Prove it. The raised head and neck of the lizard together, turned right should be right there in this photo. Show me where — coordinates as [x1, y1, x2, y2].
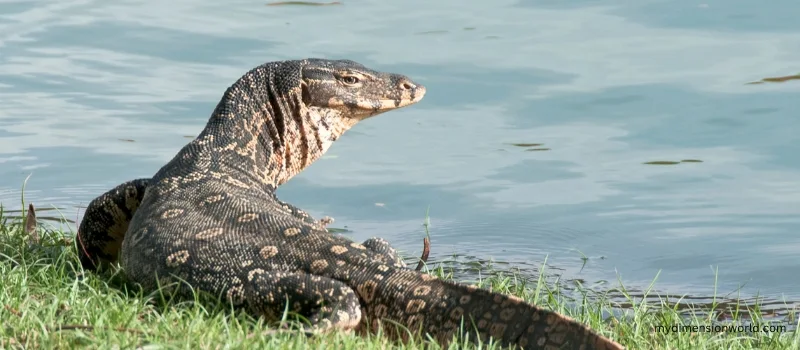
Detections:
[195, 58, 425, 188]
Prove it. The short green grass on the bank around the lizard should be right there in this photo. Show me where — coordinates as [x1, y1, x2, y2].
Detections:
[0, 204, 800, 349]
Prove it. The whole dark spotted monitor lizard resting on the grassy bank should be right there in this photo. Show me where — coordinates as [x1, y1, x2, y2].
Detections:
[78, 59, 622, 349]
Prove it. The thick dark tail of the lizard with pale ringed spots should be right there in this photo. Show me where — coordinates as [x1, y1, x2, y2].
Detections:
[358, 270, 624, 350]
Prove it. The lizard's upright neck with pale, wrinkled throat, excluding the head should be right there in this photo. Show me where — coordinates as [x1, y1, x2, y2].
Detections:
[198, 66, 357, 190]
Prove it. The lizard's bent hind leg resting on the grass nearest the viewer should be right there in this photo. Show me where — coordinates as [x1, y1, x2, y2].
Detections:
[244, 269, 361, 331]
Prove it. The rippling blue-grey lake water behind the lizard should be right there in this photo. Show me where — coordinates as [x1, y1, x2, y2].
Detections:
[0, 0, 800, 308]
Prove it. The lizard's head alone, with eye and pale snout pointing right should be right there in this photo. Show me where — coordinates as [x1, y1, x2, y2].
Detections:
[302, 59, 425, 122]
